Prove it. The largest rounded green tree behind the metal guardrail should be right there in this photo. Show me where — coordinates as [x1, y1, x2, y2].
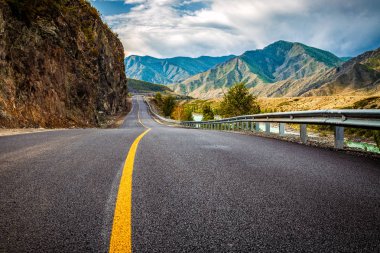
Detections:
[220, 83, 260, 117]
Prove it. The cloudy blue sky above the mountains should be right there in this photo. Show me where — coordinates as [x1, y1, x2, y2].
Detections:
[90, 0, 380, 58]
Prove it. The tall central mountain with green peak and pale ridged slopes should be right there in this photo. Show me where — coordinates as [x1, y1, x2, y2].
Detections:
[170, 41, 342, 98]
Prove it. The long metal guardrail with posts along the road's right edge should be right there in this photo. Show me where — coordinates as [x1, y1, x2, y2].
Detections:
[180, 109, 380, 149]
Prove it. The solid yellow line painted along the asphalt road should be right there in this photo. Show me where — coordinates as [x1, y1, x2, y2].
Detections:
[109, 128, 151, 252]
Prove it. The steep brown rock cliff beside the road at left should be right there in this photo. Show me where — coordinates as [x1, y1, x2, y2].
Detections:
[0, 0, 128, 127]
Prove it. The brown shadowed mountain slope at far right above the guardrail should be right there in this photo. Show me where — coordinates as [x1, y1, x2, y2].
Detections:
[251, 49, 380, 97]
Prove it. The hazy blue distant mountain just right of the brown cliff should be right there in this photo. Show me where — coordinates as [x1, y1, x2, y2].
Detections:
[125, 55, 234, 84]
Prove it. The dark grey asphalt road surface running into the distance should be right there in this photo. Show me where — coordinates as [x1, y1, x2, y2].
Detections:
[0, 98, 380, 252]
